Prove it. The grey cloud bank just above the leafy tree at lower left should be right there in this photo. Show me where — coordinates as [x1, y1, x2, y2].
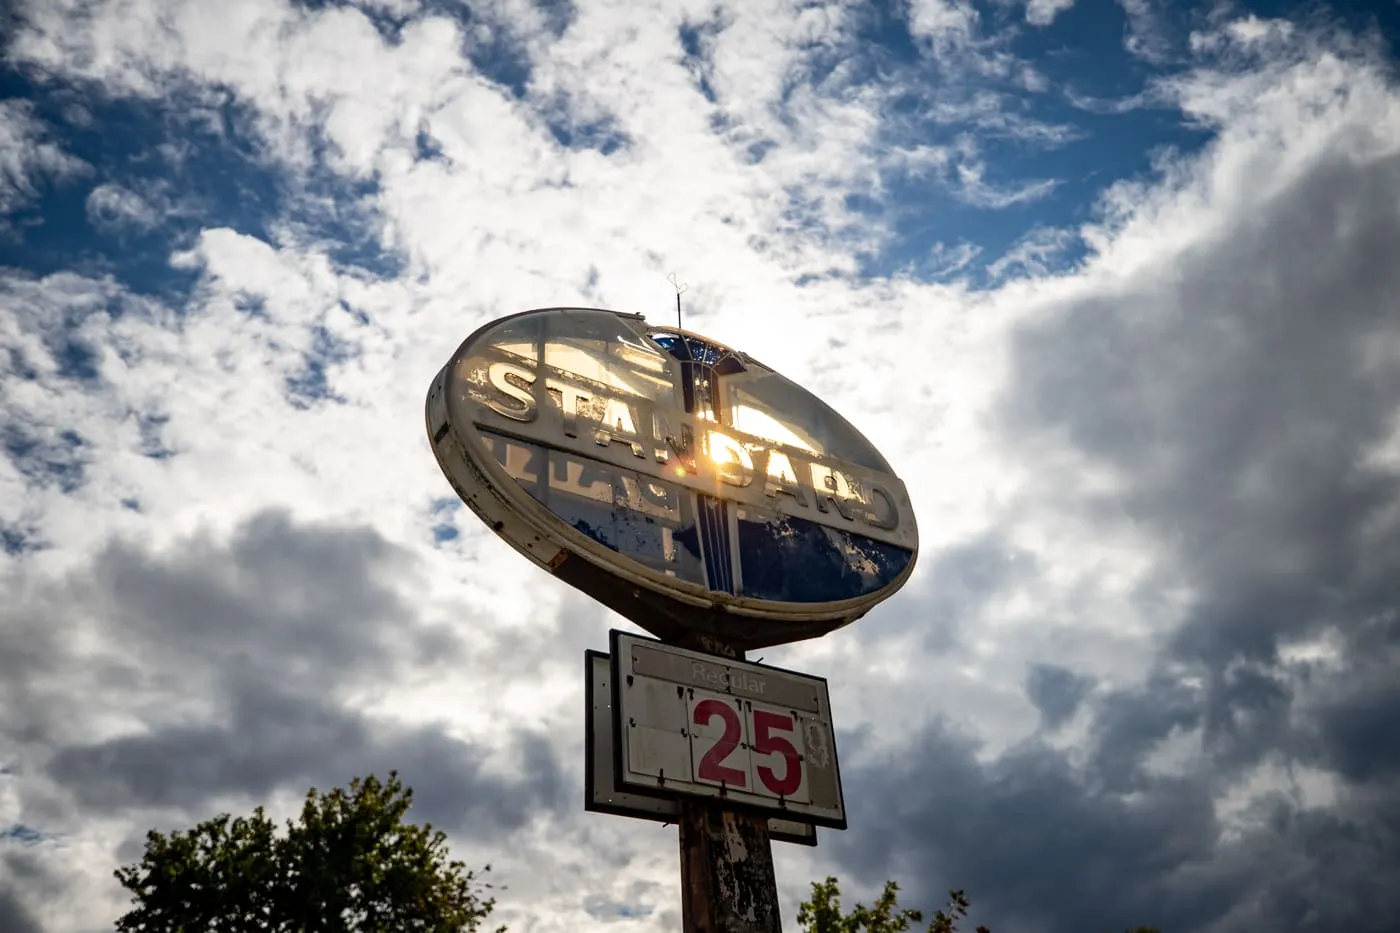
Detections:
[0, 513, 564, 835]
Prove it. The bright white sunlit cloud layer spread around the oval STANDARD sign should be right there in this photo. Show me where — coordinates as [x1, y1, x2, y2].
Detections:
[0, 0, 1400, 930]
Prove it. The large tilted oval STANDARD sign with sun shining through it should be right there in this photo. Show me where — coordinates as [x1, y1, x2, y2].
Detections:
[427, 308, 918, 650]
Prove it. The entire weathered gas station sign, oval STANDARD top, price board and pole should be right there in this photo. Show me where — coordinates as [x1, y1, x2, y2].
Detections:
[427, 308, 918, 933]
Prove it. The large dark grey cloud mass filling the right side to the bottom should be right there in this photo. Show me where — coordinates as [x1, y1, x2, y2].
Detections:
[833, 67, 1400, 933]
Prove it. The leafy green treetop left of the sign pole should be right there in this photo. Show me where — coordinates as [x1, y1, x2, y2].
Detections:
[116, 772, 505, 933]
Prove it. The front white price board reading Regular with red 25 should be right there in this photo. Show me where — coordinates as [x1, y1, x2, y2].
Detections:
[612, 630, 846, 829]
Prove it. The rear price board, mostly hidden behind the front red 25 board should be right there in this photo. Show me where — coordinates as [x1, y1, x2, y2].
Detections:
[584, 651, 816, 846]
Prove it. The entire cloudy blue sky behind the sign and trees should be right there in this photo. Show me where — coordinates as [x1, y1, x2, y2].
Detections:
[0, 0, 1400, 933]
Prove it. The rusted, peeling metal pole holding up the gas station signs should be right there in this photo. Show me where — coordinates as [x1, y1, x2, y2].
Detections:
[678, 635, 783, 933]
